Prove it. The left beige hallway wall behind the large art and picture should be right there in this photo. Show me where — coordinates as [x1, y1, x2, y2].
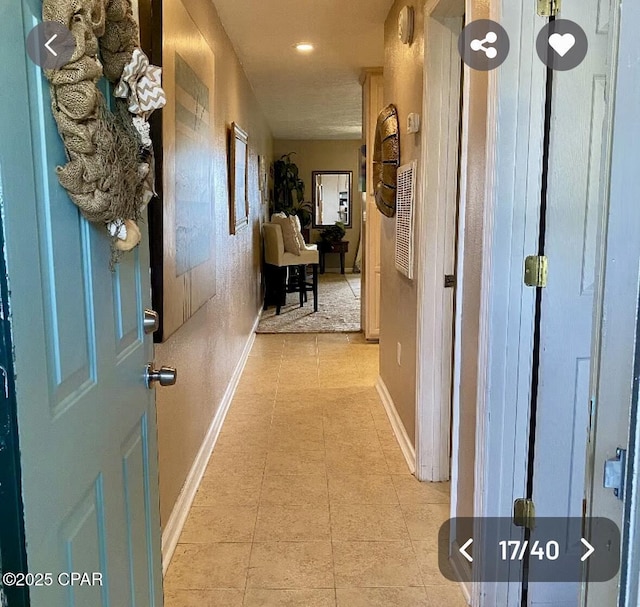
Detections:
[156, 0, 273, 525]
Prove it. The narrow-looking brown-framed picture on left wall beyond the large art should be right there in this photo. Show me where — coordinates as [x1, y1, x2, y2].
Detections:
[229, 122, 249, 234]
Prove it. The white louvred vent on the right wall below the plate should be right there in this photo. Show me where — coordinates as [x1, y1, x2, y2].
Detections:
[396, 160, 417, 279]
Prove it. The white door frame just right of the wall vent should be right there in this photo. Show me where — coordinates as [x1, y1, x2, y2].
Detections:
[415, 0, 466, 482]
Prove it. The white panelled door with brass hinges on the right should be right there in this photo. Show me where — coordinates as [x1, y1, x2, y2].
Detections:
[525, 0, 615, 607]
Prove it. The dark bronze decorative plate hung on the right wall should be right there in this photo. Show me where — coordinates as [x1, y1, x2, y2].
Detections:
[373, 105, 400, 217]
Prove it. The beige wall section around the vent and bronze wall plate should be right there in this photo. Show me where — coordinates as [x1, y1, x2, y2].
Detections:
[380, 0, 424, 442]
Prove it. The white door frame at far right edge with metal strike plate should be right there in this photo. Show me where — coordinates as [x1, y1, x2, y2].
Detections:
[585, 0, 640, 607]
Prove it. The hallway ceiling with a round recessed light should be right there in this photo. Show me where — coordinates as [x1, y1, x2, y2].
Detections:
[213, 0, 393, 139]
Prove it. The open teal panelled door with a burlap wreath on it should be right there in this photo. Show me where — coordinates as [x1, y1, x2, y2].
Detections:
[0, 0, 162, 607]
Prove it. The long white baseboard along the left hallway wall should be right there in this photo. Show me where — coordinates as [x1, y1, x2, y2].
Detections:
[162, 315, 260, 575]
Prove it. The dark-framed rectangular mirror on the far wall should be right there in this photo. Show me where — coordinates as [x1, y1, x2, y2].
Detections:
[311, 171, 353, 228]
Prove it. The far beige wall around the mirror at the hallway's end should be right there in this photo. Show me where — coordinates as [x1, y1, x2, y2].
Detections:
[273, 139, 362, 270]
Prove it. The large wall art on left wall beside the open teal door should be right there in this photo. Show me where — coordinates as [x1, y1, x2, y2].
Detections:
[150, 2, 216, 341]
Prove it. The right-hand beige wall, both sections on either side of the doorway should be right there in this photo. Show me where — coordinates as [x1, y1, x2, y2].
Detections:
[380, 0, 489, 528]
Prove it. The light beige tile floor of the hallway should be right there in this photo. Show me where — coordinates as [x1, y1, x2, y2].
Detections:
[165, 334, 466, 607]
